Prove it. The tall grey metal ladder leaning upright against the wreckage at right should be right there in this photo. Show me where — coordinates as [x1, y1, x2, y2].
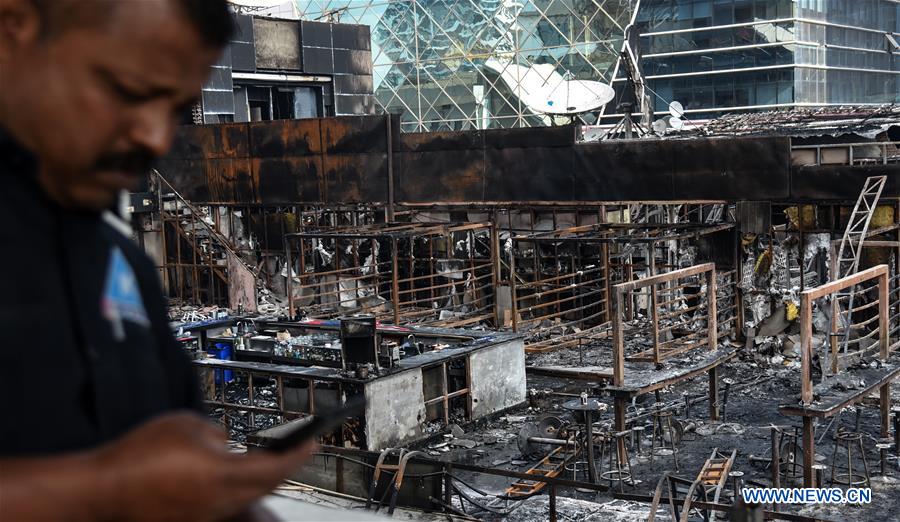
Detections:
[834, 176, 887, 353]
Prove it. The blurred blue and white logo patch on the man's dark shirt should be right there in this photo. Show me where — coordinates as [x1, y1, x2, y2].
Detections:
[102, 247, 150, 340]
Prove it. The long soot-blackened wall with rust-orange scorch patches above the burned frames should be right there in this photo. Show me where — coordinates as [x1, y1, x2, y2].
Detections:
[160, 116, 900, 204]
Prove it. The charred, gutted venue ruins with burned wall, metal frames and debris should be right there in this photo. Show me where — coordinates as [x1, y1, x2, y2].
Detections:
[131, 102, 900, 521]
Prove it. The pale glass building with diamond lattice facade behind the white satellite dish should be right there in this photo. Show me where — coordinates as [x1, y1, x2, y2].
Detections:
[295, 0, 637, 132]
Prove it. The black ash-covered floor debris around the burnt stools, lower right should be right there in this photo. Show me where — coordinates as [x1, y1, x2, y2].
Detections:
[406, 344, 900, 522]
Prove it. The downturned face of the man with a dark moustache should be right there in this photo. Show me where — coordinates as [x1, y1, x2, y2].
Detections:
[0, 0, 219, 210]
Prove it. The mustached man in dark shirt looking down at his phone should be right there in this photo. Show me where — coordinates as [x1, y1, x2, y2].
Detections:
[0, 0, 310, 520]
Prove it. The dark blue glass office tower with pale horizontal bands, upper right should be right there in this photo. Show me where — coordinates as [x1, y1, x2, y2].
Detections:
[628, 0, 900, 118]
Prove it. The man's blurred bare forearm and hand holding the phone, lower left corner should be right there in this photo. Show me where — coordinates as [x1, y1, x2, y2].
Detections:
[0, 413, 315, 521]
